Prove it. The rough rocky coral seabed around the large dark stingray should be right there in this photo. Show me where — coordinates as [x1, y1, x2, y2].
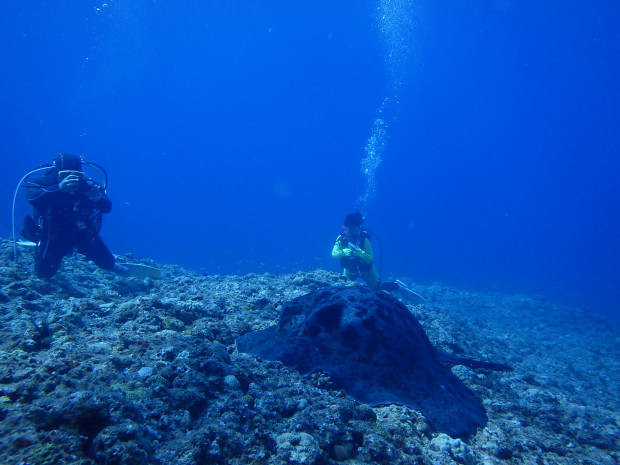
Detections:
[0, 240, 620, 465]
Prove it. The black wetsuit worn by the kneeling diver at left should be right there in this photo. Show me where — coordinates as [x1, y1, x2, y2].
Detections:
[26, 168, 114, 278]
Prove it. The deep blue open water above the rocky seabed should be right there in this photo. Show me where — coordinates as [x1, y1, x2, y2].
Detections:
[0, 0, 620, 316]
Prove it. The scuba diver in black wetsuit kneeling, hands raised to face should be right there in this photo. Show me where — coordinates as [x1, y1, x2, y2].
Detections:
[22, 153, 117, 278]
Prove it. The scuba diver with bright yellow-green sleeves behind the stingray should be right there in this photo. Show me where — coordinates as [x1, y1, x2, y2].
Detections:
[332, 211, 381, 289]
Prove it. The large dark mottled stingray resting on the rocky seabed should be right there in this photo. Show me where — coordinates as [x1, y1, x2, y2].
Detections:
[236, 286, 510, 437]
